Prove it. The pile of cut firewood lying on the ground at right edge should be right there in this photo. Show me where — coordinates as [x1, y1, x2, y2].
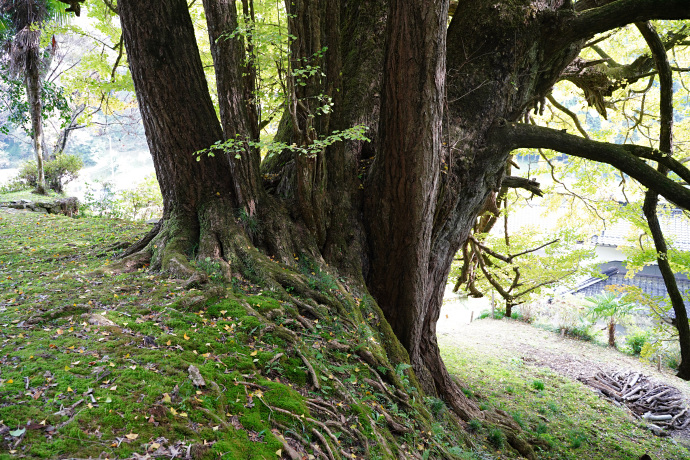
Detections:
[581, 372, 690, 431]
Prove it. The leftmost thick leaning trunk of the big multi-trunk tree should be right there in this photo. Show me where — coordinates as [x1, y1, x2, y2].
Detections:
[119, 0, 245, 277]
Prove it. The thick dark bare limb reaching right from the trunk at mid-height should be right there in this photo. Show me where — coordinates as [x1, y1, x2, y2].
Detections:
[492, 122, 690, 209]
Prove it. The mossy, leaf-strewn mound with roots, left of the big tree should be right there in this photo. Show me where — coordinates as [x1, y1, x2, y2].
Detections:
[0, 209, 472, 459]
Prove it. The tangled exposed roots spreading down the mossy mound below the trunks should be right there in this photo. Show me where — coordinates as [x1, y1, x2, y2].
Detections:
[114, 215, 535, 460]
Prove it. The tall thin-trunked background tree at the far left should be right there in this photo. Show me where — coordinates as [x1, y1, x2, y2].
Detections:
[0, 0, 65, 194]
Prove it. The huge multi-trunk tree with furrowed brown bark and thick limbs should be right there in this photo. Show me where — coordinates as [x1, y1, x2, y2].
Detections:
[103, 0, 690, 442]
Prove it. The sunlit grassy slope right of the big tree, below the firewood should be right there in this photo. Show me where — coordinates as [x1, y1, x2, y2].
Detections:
[440, 332, 690, 460]
